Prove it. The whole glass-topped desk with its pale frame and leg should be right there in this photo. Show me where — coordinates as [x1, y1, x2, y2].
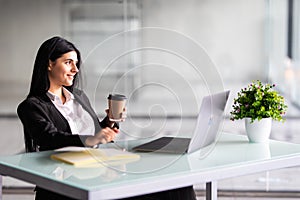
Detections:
[0, 133, 300, 200]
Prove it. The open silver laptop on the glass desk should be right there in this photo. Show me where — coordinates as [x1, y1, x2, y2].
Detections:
[132, 91, 230, 154]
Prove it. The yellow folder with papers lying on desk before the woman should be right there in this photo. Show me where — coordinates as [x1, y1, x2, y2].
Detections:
[51, 147, 140, 166]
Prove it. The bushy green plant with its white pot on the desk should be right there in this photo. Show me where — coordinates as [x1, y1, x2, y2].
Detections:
[230, 80, 287, 142]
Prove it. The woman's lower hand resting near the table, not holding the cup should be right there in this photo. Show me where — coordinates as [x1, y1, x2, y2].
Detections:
[85, 127, 119, 147]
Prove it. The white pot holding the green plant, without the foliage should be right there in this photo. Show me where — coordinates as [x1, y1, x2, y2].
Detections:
[245, 118, 272, 143]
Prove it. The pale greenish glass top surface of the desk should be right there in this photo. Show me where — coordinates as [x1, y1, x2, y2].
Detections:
[0, 133, 300, 191]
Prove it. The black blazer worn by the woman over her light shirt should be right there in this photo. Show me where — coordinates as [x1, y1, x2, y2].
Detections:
[17, 89, 108, 152]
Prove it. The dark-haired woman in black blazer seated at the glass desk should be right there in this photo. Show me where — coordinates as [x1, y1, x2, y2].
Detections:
[17, 37, 195, 200]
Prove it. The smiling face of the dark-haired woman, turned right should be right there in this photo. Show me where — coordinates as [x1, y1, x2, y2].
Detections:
[48, 51, 78, 91]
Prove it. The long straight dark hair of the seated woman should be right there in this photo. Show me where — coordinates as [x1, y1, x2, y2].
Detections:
[28, 36, 81, 97]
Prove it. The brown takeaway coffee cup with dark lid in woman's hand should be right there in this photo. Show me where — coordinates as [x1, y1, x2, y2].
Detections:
[107, 94, 127, 122]
